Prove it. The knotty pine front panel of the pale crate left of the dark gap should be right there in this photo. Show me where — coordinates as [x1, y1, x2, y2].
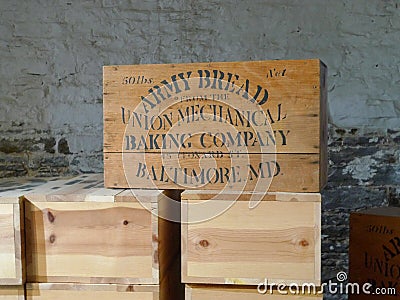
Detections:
[25, 201, 158, 283]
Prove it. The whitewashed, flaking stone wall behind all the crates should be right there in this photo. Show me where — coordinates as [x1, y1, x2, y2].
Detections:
[0, 0, 400, 299]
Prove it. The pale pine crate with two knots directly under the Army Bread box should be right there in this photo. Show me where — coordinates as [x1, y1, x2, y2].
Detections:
[181, 191, 321, 285]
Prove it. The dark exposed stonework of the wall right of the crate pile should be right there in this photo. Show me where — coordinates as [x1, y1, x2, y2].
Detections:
[322, 127, 400, 299]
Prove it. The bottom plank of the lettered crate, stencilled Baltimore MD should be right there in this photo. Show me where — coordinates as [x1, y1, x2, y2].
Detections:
[104, 153, 320, 192]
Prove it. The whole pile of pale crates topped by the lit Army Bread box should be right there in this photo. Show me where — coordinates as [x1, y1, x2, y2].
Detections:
[2, 60, 327, 300]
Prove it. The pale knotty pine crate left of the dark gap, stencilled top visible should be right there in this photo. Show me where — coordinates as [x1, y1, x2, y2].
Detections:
[24, 174, 180, 284]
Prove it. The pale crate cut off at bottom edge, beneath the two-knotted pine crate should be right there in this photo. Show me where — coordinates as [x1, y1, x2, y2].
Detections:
[185, 285, 322, 300]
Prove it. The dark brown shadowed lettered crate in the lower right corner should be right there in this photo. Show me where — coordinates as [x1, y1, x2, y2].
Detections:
[349, 207, 400, 300]
